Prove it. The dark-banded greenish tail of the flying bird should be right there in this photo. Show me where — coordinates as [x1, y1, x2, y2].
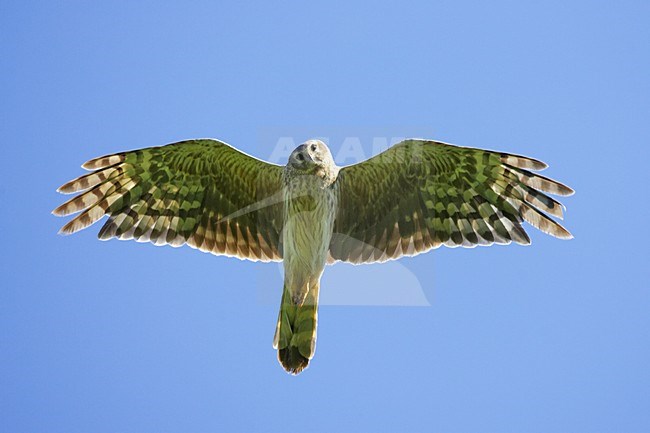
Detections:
[273, 283, 319, 374]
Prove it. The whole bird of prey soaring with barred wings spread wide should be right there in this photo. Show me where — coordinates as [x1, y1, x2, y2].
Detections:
[53, 139, 573, 374]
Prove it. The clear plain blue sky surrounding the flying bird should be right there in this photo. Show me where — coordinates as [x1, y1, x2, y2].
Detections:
[0, 1, 650, 432]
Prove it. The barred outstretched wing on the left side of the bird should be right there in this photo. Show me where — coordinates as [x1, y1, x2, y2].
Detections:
[53, 139, 283, 261]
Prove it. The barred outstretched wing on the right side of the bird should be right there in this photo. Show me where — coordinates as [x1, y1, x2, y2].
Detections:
[330, 140, 573, 263]
